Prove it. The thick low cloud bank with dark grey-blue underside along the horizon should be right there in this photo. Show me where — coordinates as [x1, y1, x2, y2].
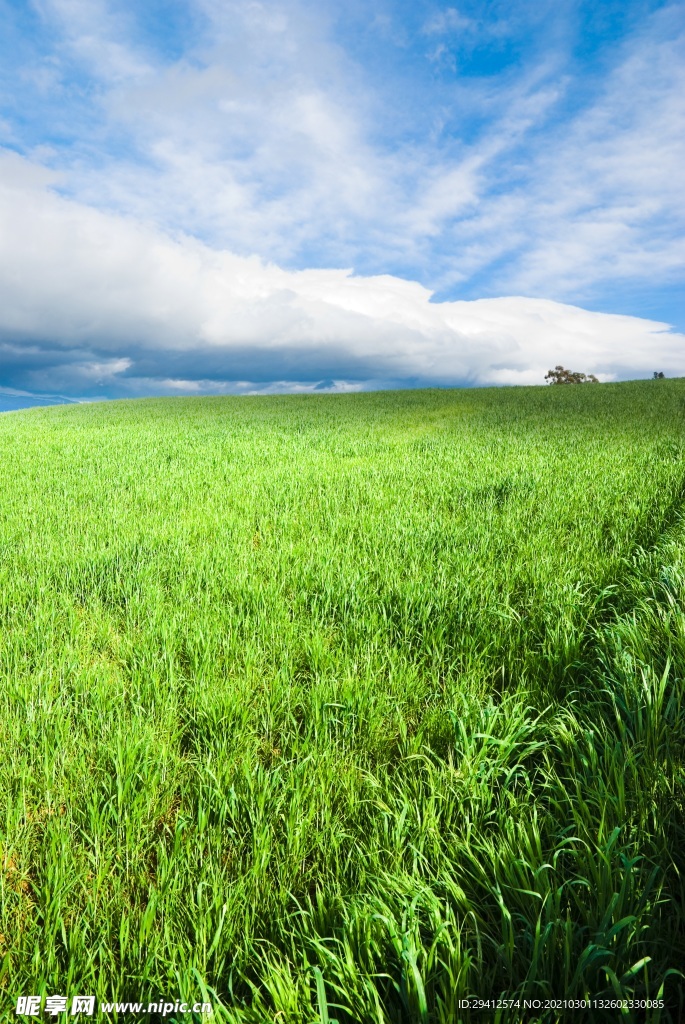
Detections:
[0, 152, 685, 398]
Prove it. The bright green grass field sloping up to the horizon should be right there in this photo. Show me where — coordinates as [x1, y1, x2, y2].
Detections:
[0, 381, 685, 1024]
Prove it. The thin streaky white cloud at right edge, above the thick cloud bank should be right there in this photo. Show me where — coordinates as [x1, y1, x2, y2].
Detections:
[444, 7, 685, 297]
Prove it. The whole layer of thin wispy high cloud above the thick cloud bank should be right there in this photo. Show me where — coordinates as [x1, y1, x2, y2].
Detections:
[17, 0, 685, 301]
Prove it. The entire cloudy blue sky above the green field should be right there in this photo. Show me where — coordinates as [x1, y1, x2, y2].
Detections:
[0, 0, 685, 404]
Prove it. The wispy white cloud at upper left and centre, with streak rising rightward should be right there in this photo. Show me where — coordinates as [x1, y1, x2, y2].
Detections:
[14, 0, 553, 272]
